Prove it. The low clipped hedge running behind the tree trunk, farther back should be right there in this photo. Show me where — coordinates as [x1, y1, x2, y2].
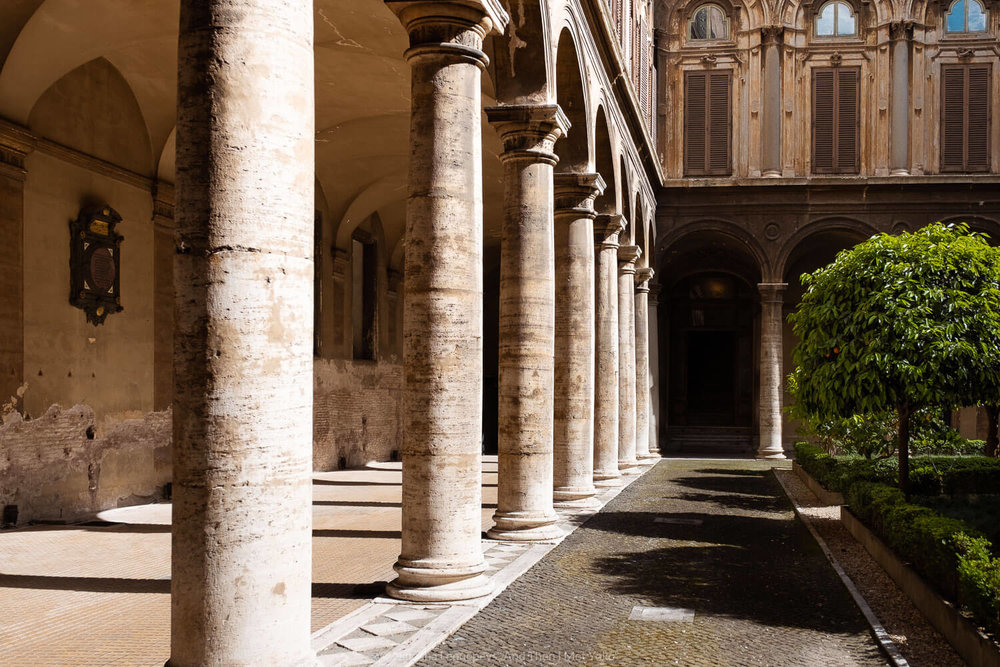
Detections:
[795, 442, 1000, 496]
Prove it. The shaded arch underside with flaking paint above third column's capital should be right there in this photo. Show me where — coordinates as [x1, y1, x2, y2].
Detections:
[489, 2, 555, 104]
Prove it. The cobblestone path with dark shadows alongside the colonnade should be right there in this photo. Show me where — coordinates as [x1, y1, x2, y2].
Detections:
[419, 459, 885, 667]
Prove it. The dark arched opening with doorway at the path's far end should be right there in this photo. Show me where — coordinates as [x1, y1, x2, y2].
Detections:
[658, 230, 761, 455]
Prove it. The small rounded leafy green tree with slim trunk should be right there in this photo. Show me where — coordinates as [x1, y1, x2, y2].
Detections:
[789, 223, 1000, 493]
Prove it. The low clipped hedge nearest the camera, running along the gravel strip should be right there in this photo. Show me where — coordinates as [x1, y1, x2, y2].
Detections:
[846, 482, 1000, 635]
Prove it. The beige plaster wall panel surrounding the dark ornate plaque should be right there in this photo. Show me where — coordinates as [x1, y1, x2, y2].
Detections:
[24, 152, 153, 423]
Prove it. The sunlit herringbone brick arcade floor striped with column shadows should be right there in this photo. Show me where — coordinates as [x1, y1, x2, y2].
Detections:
[0, 456, 497, 667]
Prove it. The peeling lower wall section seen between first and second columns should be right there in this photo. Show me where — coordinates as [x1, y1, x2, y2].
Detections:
[313, 359, 403, 471]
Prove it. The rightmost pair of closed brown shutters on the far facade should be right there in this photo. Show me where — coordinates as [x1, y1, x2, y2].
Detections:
[940, 64, 991, 171]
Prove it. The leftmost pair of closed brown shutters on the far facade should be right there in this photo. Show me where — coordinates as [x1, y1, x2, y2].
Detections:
[684, 70, 732, 176]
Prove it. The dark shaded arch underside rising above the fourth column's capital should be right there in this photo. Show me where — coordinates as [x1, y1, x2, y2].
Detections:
[556, 28, 590, 173]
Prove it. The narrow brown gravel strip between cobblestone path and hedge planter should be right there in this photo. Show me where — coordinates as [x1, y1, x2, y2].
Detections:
[774, 470, 965, 667]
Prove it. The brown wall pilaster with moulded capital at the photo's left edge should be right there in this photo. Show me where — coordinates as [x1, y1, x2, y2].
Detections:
[0, 120, 35, 408]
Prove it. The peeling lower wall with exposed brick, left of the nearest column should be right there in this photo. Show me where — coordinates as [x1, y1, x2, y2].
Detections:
[0, 405, 171, 525]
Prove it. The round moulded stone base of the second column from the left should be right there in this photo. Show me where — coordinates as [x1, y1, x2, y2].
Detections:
[385, 560, 493, 602]
